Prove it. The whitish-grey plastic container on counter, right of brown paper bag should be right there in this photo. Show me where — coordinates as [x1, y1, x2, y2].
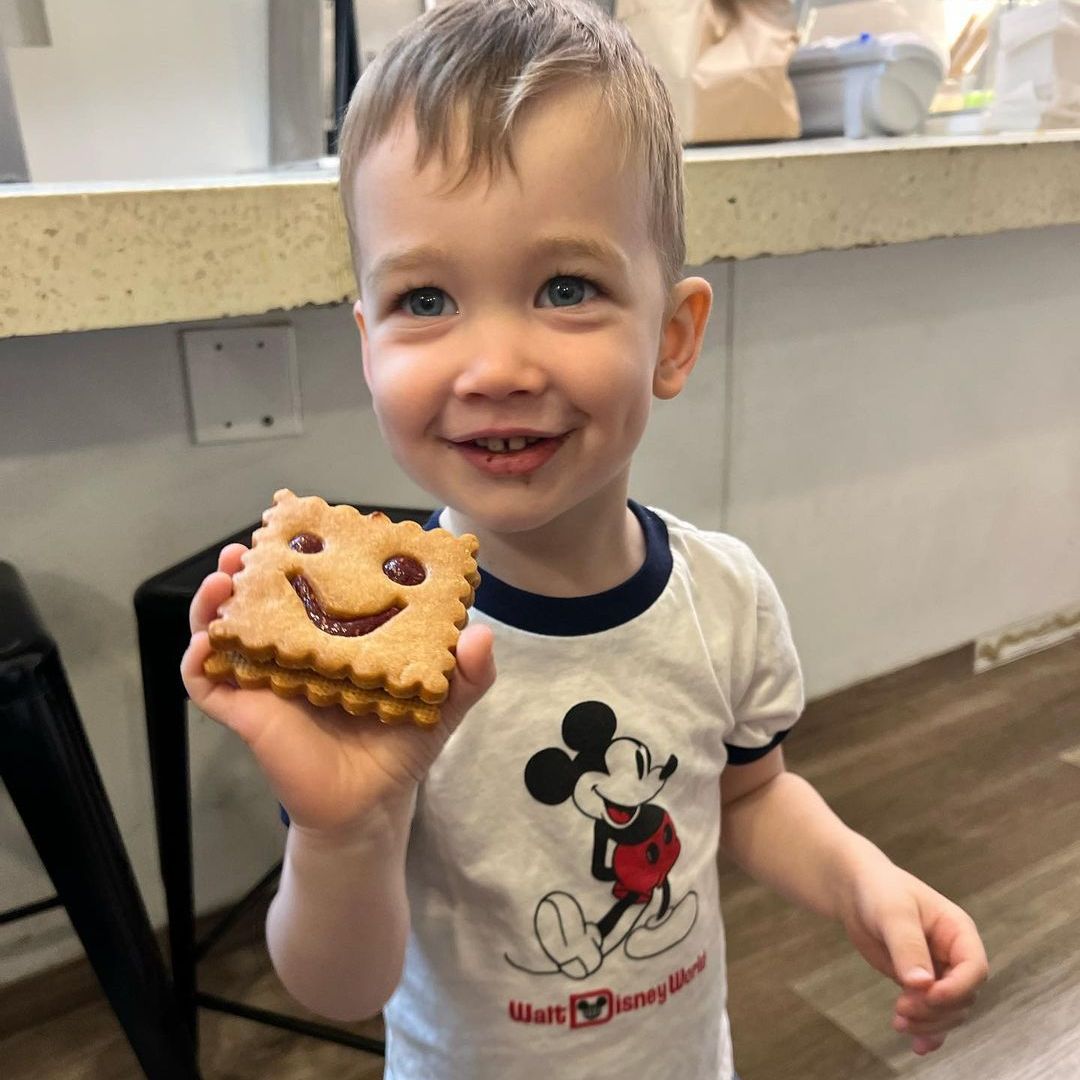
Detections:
[788, 33, 945, 138]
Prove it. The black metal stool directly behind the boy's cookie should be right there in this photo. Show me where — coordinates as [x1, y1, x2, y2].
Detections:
[135, 503, 431, 1054]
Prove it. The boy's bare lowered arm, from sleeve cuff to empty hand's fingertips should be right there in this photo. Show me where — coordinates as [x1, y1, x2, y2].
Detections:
[720, 746, 987, 1054]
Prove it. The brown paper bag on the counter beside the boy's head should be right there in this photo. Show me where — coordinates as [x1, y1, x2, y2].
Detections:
[615, 0, 799, 144]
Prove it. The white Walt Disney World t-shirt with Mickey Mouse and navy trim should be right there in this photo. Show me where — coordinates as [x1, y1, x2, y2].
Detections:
[386, 503, 804, 1080]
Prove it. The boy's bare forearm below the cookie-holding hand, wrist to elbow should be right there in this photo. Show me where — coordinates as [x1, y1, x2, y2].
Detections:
[267, 796, 415, 1022]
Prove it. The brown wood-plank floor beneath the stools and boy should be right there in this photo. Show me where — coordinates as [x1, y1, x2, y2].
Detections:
[0, 639, 1080, 1080]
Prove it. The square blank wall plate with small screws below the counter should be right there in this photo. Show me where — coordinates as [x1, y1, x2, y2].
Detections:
[180, 324, 303, 443]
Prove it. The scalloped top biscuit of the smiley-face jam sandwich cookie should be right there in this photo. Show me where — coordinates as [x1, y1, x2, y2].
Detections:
[210, 490, 480, 715]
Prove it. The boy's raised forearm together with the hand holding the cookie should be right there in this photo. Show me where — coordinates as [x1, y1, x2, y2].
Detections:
[180, 544, 495, 1020]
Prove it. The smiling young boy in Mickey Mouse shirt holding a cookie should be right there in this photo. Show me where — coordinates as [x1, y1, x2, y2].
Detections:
[184, 0, 987, 1080]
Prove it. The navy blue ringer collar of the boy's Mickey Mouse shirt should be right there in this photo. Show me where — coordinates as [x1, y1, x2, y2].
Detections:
[424, 499, 672, 637]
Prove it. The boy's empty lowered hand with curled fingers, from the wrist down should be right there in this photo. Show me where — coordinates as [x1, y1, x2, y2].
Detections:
[842, 864, 988, 1054]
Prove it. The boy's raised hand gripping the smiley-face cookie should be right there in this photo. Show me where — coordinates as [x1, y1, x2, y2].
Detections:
[180, 543, 495, 833]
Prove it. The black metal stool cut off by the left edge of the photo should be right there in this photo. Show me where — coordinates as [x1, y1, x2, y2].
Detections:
[0, 562, 199, 1080]
